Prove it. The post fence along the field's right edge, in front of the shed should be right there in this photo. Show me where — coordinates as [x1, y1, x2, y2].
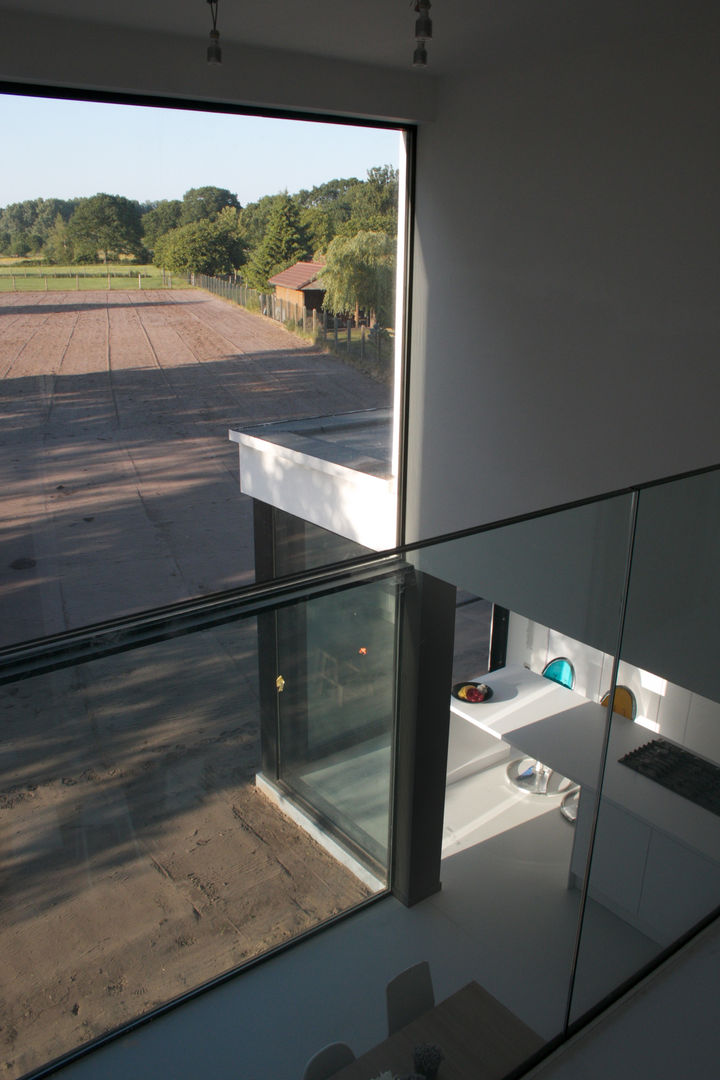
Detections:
[188, 273, 394, 381]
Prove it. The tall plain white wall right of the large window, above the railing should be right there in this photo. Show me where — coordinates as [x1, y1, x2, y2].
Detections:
[408, 27, 720, 539]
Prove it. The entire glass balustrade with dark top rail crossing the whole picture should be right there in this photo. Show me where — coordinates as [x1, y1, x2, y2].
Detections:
[0, 470, 720, 1080]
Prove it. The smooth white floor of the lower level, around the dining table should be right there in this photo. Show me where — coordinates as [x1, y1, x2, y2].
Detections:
[59, 721, 653, 1080]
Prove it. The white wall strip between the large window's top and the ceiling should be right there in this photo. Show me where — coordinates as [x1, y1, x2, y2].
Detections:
[0, 3, 435, 122]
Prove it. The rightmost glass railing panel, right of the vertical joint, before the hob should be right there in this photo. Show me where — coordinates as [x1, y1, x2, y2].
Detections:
[572, 473, 720, 1018]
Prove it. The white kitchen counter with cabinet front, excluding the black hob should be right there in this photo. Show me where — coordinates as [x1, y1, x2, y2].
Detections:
[450, 666, 720, 942]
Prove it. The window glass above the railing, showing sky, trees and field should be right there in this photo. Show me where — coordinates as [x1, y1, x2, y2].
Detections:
[0, 94, 406, 647]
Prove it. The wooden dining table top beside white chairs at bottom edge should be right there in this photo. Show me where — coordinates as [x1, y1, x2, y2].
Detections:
[334, 982, 544, 1080]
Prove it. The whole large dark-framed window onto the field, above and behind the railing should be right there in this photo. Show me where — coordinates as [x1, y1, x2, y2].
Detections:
[0, 86, 406, 1077]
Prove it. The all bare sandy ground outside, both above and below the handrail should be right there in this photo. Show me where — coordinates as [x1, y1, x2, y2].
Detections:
[0, 291, 388, 1077]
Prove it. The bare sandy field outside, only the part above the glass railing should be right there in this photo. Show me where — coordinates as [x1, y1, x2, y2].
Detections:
[0, 291, 390, 645]
